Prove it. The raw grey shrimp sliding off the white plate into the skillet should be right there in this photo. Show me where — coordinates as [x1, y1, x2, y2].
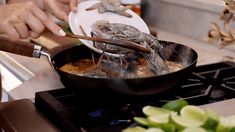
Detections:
[91, 21, 169, 74]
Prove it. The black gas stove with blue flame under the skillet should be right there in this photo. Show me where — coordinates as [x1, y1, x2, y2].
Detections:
[35, 62, 235, 132]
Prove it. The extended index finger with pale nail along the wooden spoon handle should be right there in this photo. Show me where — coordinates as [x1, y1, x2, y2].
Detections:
[31, 5, 65, 36]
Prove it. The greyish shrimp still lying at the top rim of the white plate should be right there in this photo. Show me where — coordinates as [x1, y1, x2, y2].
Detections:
[86, 0, 132, 17]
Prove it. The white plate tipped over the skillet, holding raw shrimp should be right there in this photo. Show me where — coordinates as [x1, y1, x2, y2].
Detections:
[69, 0, 150, 56]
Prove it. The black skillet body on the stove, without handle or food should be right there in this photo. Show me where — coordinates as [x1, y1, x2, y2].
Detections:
[52, 41, 198, 95]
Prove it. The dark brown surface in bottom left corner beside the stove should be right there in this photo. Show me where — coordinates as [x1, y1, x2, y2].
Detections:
[0, 99, 60, 132]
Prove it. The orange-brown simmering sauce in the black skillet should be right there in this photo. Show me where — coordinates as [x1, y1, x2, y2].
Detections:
[60, 58, 183, 78]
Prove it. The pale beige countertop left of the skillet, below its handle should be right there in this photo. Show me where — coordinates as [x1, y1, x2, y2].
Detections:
[1, 53, 64, 100]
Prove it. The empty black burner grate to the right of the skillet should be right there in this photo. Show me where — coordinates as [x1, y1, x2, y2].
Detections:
[164, 63, 235, 104]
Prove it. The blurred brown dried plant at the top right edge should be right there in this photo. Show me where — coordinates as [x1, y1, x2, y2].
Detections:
[208, 0, 235, 48]
